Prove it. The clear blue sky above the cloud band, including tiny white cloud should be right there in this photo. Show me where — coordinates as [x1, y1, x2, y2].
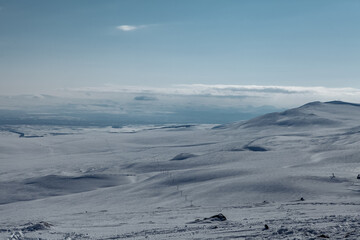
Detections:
[0, 0, 360, 94]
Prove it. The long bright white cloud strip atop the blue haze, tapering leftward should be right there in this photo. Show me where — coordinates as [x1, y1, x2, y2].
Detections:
[72, 84, 360, 108]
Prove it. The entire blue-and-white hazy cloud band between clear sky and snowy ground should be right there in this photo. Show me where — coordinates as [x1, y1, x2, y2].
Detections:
[0, 84, 360, 126]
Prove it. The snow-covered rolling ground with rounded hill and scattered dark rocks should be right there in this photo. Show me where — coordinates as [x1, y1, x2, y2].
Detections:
[0, 102, 360, 240]
